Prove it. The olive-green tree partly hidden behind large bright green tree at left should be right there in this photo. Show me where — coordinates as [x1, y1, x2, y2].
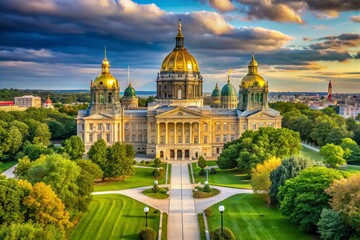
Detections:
[76, 159, 103, 211]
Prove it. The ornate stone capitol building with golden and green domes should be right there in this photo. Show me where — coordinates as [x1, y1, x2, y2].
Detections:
[77, 21, 282, 160]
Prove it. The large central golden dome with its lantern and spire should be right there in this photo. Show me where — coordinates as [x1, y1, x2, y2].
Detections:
[160, 19, 199, 73]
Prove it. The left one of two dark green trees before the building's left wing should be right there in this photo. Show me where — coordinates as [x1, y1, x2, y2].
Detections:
[88, 139, 107, 181]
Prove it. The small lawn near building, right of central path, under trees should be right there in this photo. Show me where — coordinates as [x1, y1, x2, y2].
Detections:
[193, 163, 251, 189]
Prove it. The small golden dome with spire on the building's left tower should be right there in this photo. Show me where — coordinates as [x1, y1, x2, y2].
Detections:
[91, 49, 119, 88]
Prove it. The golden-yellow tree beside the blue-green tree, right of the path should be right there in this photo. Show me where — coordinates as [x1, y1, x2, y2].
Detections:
[251, 157, 281, 204]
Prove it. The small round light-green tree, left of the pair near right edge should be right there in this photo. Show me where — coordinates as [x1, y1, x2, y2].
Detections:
[320, 143, 346, 168]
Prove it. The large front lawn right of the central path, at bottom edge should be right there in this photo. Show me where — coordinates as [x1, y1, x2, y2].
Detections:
[206, 194, 314, 240]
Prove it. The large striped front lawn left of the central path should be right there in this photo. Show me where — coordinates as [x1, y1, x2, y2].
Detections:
[70, 195, 160, 240]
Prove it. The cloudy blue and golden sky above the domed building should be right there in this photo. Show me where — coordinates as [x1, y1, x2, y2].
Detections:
[0, 0, 360, 93]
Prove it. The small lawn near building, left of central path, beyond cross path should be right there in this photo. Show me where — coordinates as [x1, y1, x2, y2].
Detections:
[94, 168, 165, 192]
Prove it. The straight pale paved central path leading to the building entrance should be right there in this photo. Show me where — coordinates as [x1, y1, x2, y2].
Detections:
[168, 162, 200, 240]
